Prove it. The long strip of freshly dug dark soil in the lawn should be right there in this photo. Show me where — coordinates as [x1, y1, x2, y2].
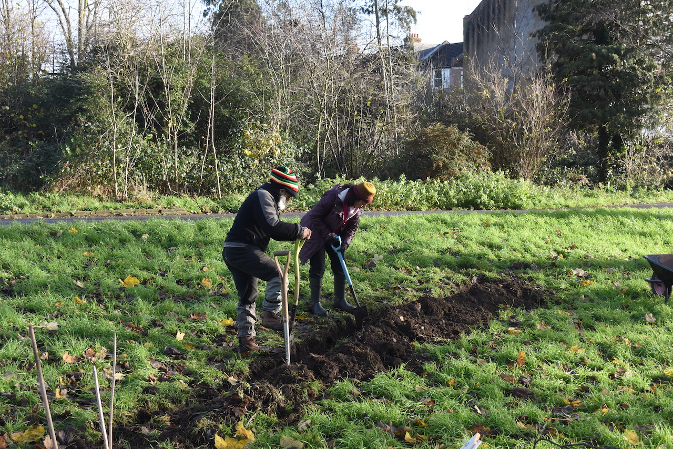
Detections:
[84, 278, 554, 449]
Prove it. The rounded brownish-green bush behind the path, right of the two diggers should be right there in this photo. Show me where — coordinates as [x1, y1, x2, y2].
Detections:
[397, 123, 490, 181]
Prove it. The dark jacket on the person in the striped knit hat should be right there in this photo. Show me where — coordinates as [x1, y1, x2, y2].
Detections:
[225, 183, 303, 251]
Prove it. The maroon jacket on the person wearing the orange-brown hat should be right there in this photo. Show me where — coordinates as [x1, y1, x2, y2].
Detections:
[300, 184, 363, 264]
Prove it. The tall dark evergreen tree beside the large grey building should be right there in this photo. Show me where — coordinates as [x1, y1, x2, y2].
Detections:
[536, 0, 673, 182]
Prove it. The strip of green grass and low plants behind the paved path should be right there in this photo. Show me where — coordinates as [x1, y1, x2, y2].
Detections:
[0, 173, 673, 215]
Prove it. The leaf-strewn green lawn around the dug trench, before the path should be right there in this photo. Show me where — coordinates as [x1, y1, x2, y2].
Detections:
[0, 208, 673, 449]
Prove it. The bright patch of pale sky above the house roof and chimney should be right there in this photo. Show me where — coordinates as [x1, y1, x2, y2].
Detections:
[402, 0, 481, 44]
